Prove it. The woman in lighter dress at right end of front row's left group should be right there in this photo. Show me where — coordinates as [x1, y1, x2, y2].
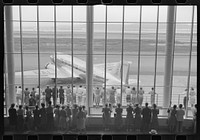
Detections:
[76, 107, 86, 133]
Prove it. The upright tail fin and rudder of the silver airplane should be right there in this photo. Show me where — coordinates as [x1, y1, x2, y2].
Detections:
[111, 61, 131, 84]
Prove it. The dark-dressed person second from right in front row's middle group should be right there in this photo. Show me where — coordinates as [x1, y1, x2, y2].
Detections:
[141, 103, 151, 131]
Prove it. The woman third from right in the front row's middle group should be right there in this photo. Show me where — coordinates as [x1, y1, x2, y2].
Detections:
[134, 104, 142, 132]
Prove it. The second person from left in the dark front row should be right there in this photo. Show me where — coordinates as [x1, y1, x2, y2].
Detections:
[17, 105, 24, 131]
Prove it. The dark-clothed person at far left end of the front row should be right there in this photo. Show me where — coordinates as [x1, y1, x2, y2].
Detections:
[8, 103, 17, 131]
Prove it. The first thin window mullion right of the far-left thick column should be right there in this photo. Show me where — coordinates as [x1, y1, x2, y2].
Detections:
[19, 6, 24, 105]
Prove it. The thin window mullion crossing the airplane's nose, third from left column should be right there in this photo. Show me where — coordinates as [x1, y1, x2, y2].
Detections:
[54, 6, 57, 99]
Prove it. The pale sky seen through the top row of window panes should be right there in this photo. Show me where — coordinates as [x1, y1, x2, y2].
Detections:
[8, 5, 197, 22]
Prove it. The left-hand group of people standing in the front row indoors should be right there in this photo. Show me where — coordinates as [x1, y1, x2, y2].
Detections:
[9, 101, 87, 132]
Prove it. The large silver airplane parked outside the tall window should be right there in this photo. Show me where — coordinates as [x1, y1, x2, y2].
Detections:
[15, 54, 137, 88]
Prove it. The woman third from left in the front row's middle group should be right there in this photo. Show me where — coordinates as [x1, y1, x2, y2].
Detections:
[126, 104, 133, 131]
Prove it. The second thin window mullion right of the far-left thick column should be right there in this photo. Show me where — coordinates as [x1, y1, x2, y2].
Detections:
[37, 6, 41, 106]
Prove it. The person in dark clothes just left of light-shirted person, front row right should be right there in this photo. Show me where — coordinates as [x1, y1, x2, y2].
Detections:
[169, 105, 177, 132]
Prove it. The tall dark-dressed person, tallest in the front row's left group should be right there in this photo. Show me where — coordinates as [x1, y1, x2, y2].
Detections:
[46, 101, 54, 131]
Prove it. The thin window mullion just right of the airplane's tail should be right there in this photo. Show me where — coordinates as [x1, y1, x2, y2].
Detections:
[137, 6, 142, 97]
